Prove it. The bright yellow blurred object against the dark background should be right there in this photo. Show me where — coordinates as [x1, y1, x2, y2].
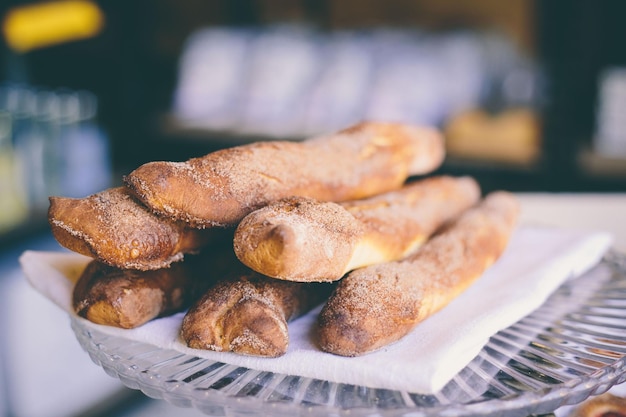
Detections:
[2, 0, 104, 52]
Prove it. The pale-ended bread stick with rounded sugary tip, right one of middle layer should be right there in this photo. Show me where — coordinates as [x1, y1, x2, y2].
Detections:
[234, 176, 480, 282]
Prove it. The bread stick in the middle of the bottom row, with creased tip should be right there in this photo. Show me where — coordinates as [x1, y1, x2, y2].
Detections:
[181, 269, 332, 357]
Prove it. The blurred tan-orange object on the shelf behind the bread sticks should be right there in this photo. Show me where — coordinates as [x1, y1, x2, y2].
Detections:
[445, 108, 541, 164]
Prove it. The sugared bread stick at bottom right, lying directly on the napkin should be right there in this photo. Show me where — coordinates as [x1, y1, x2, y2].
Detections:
[317, 192, 519, 356]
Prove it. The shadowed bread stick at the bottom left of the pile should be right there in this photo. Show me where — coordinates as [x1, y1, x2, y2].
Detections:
[72, 256, 219, 329]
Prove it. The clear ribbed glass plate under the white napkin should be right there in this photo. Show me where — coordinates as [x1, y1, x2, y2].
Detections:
[72, 252, 626, 417]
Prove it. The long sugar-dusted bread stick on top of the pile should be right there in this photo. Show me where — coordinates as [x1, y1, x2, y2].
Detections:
[125, 122, 444, 228]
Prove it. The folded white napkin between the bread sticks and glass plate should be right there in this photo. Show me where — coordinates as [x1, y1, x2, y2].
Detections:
[20, 226, 612, 394]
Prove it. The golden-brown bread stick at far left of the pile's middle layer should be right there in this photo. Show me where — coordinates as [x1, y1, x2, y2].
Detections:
[48, 187, 226, 270]
